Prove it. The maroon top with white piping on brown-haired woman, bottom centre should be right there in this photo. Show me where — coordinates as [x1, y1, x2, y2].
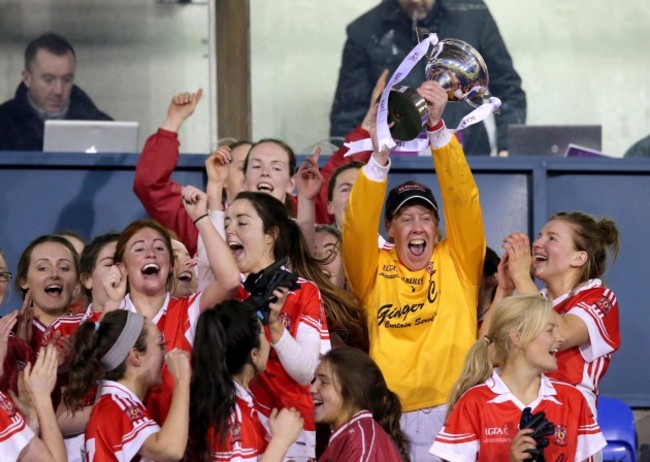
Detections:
[318, 411, 402, 462]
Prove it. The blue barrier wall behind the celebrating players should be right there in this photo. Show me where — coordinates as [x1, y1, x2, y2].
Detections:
[0, 152, 650, 407]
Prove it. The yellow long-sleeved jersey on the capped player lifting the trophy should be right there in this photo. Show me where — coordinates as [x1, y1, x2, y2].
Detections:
[342, 137, 486, 411]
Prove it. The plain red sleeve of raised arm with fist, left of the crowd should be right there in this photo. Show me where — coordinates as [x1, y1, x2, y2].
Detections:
[133, 128, 199, 255]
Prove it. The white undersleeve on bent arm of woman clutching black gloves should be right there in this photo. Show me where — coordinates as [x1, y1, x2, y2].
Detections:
[272, 323, 321, 385]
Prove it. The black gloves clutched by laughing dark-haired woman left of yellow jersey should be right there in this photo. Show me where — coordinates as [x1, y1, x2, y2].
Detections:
[244, 258, 300, 325]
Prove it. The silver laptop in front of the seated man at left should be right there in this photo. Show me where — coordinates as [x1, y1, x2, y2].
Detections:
[43, 120, 138, 154]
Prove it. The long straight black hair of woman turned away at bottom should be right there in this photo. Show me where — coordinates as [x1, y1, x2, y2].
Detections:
[189, 300, 262, 461]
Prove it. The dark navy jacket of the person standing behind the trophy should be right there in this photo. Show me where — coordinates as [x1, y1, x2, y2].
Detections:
[330, 0, 526, 155]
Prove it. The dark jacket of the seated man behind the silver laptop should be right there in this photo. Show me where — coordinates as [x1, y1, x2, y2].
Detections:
[0, 83, 113, 151]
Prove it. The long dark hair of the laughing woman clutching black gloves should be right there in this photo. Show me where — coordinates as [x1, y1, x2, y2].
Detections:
[235, 191, 367, 348]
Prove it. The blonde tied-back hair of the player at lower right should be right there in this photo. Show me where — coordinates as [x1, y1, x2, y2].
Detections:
[448, 295, 553, 412]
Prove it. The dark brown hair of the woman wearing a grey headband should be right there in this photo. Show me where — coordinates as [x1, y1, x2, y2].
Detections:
[63, 310, 147, 411]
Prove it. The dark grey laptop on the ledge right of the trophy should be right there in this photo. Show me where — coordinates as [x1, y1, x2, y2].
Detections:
[508, 125, 602, 157]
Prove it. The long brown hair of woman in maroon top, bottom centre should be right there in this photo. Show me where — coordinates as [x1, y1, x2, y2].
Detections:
[321, 347, 410, 462]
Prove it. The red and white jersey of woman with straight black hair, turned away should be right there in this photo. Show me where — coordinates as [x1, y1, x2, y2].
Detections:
[208, 382, 270, 462]
